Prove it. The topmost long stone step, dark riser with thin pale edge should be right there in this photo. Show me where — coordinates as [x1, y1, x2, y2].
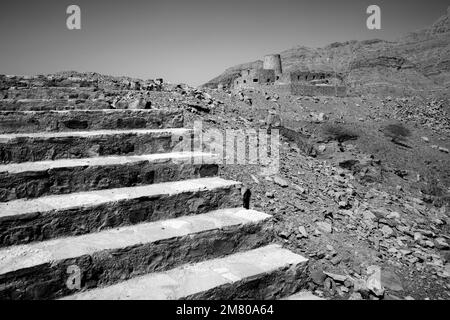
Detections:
[0, 109, 183, 133]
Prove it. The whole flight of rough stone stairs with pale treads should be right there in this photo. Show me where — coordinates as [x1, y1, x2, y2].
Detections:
[0, 84, 307, 299]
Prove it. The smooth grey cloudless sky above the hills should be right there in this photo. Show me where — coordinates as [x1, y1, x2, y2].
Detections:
[0, 0, 449, 85]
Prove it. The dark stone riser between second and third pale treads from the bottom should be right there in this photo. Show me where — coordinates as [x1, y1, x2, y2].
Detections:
[0, 185, 242, 247]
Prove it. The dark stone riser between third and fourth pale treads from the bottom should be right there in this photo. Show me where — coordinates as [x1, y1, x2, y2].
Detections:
[0, 161, 218, 202]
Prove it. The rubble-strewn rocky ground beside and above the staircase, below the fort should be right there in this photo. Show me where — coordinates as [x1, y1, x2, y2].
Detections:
[0, 73, 450, 299]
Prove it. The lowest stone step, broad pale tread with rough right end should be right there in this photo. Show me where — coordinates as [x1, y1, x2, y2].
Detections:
[64, 245, 308, 300]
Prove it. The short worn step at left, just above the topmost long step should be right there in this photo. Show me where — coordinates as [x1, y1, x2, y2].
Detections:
[0, 99, 112, 111]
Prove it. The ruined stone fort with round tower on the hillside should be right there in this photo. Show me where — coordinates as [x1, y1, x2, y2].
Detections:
[233, 54, 347, 96]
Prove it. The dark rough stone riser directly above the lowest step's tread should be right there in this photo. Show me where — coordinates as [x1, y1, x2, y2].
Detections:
[0, 221, 271, 299]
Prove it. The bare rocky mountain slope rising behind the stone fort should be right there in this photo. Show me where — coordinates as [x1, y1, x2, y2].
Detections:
[204, 7, 450, 95]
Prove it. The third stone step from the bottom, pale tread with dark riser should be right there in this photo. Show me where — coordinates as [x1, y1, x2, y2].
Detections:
[0, 177, 243, 246]
